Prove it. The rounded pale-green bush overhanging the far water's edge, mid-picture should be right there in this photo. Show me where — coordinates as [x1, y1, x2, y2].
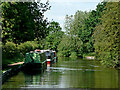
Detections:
[58, 35, 82, 57]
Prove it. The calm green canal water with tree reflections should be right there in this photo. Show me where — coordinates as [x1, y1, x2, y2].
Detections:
[2, 58, 120, 88]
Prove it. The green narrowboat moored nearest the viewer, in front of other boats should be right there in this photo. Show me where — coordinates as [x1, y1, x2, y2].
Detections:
[24, 50, 47, 70]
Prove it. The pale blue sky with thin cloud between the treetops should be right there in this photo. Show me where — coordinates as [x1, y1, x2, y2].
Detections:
[41, 0, 101, 31]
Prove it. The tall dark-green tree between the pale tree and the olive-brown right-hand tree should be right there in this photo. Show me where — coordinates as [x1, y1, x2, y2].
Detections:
[78, 2, 106, 53]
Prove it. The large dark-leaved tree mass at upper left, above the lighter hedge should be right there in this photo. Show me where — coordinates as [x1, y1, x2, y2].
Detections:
[1, 2, 50, 43]
